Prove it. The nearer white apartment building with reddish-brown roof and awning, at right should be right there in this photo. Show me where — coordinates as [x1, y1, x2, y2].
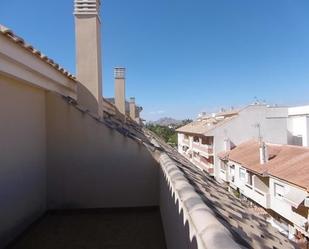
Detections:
[219, 140, 309, 244]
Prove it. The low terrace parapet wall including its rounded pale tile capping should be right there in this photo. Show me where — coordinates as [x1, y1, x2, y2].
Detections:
[160, 154, 240, 249]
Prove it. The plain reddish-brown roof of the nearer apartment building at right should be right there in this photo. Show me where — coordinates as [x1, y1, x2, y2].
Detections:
[218, 140, 309, 191]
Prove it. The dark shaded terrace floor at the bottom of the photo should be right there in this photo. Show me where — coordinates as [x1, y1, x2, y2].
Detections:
[8, 208, 166, 249]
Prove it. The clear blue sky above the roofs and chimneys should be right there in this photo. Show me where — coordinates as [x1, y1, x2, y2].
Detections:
[0, 0, 309, 120]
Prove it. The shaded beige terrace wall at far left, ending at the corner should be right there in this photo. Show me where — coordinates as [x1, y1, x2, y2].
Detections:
[0, 75, 46, 248]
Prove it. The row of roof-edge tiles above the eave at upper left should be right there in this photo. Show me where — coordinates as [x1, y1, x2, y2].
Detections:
[0, 24, 76, 81]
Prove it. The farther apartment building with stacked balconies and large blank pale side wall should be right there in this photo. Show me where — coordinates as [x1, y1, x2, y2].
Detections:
[177, 104, 288, 181]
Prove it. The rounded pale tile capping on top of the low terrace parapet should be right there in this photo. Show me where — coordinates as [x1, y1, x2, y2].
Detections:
[160, 153, 241, 249]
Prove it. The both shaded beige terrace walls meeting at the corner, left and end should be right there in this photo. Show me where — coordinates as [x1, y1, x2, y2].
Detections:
[0, 74, 159, 248]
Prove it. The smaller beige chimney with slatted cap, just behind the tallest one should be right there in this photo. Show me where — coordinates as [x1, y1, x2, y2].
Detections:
[114, 67, 126, 115]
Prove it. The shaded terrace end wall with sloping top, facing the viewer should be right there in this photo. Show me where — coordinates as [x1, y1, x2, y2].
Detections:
[46, 93, 159, 209]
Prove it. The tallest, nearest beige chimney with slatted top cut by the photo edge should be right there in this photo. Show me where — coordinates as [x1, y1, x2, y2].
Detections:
[74, 0, 103, 116]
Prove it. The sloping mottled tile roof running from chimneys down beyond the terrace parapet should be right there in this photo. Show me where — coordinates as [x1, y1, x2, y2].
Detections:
[64, 97, 294, 249]
